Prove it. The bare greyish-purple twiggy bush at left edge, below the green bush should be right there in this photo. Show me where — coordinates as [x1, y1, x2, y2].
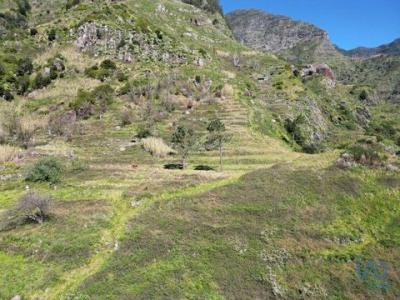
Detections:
[0, 192, 51, 231]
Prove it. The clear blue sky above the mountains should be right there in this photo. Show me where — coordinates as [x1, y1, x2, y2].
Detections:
[221, 0, 400, 50]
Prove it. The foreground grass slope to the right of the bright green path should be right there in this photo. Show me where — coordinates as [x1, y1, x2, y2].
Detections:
[73, 166, 400, 299]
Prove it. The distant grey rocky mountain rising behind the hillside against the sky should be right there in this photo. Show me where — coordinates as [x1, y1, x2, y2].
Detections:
[226, 10, 340, 63]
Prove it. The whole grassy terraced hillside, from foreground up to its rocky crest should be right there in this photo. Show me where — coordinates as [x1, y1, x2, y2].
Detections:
[0, 0, 400, 299]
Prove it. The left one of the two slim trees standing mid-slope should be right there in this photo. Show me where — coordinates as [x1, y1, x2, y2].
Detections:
[171, 125, 197, 169]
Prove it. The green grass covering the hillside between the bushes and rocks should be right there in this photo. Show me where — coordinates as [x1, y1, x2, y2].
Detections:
[0, 0, 400, 299]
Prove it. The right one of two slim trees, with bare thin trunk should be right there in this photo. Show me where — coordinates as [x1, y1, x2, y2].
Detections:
[206, 118, 230, 171]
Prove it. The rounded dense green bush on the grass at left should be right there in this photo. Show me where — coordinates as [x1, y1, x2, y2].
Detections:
[25, 157, 64, 184]
